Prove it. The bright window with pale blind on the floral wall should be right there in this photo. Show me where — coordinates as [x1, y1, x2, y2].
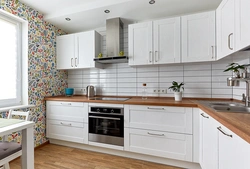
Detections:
[0, 13, 22, 107]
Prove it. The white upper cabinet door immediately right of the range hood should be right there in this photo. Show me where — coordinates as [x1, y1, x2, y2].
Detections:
[128, 22, 153, 65]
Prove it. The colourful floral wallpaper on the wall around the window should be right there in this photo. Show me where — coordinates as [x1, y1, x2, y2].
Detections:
[0, 0, 67, 146]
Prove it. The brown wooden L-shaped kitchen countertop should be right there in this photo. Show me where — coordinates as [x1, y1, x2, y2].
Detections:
[44, 96, 250, 143]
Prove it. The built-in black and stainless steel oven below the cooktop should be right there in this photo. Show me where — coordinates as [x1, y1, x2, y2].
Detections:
[89, 106, 124, 146]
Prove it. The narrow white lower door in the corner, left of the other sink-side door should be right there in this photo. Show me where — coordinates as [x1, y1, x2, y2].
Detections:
[200, 111, 218, 169]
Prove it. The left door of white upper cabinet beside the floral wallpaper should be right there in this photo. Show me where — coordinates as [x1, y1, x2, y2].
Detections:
[56, 34, 76, 69]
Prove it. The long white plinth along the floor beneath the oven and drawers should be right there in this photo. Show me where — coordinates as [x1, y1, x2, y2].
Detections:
[50, 139, 201, 169]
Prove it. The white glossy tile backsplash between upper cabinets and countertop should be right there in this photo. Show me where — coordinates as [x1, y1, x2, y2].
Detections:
[68, 27, 250, 99]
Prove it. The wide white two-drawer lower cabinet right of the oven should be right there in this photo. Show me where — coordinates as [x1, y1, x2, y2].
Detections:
[124, 105, 193, 161]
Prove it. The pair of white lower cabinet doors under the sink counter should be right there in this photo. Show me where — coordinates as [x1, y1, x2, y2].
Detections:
[200, 111, 250, 169]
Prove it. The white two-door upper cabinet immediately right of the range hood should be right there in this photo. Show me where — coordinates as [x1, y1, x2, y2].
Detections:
[129, 17, 180, 65]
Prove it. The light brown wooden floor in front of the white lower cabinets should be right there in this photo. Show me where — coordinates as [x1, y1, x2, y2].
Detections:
[10, 144, 183, 169]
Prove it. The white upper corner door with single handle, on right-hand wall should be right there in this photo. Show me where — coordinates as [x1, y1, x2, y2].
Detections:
[216, 0, 235, 59]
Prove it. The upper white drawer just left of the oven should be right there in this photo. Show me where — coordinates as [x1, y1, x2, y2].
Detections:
[46, 101, 88, 123]
